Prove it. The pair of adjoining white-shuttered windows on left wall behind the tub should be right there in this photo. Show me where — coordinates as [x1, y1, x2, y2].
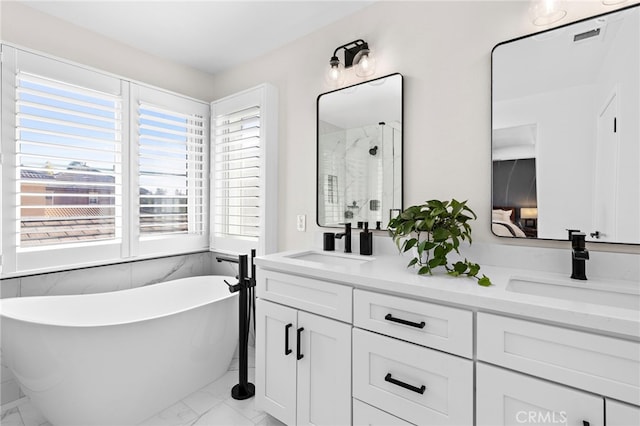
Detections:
[0, 45, 210, 274]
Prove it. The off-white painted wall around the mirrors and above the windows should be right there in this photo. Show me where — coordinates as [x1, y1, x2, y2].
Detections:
[0, 0, 637, 255]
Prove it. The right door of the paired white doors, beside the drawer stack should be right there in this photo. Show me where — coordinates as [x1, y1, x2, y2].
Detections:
[297, 312, 351, 425]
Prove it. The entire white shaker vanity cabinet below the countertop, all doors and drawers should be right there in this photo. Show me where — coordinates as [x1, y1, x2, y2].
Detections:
[255, 260, 640, 426]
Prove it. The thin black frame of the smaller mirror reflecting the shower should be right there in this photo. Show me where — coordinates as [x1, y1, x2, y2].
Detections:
[315, 72, 405, 232]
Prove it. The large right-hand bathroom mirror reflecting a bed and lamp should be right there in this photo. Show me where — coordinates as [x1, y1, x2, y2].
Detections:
[492, 5, 640, 244]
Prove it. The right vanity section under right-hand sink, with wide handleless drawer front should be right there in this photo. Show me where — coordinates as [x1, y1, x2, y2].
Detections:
[476, 312, 640, 426]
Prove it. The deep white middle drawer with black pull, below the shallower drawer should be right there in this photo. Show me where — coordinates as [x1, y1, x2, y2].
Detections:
[353, 328, 473, 425]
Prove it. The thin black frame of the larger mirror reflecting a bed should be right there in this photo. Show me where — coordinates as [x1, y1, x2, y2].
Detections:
[489, 3, 640, 246]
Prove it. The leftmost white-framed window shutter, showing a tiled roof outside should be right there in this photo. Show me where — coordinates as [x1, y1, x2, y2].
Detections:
[1, 45, 128, 274]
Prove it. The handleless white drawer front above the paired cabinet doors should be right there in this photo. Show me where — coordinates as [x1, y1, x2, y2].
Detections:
[256, 269, 353, 323]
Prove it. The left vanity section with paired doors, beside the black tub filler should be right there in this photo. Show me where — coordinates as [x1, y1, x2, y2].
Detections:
[255, 271, 351, 425]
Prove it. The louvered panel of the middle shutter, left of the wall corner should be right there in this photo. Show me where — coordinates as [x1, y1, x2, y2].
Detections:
[138, 102, 207, 236]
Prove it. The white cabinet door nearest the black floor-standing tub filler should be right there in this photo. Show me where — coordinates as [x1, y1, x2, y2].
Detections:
[255, 299, 298, 425]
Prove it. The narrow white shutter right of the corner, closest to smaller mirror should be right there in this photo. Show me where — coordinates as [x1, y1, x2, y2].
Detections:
[211, 84, 278, 255]
